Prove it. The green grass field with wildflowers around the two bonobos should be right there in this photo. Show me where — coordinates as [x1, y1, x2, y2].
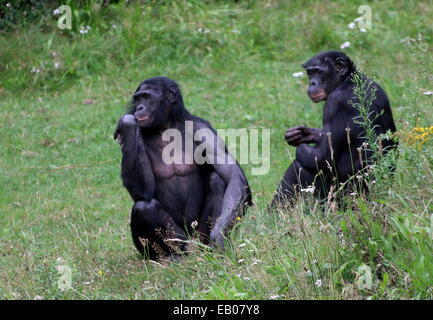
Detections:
[0, 0, 433, 299]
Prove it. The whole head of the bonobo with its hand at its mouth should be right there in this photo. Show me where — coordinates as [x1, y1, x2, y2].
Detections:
[130, 77, 185, 128]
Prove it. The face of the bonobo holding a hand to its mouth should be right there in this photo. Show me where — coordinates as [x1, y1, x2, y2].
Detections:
[133, 82, 170, 128]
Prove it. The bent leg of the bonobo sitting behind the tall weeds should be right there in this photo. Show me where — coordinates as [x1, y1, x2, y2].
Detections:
[270, 160, 324, 208]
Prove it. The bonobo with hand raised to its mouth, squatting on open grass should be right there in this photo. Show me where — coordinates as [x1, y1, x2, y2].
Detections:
[114, 77, 251, 259]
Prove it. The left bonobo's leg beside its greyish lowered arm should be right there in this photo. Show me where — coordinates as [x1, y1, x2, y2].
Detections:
[197, 172, 227, 243]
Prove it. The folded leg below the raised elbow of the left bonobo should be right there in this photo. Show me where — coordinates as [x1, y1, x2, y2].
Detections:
[131, 199, 186, 260]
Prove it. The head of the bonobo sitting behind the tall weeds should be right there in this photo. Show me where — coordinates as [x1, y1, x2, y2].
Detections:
[302, 51, 356, 102]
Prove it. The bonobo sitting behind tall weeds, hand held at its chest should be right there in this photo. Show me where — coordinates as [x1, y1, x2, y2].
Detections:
[271, 51, 396, 207]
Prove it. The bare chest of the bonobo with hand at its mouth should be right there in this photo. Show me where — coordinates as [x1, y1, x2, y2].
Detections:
[143, 135, 199, 180]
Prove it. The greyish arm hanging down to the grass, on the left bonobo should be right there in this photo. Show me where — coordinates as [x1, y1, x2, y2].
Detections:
[196, 122, 251, 248]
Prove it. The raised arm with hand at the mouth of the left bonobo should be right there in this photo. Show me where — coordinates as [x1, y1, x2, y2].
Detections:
[114, 114, 155, 202]
